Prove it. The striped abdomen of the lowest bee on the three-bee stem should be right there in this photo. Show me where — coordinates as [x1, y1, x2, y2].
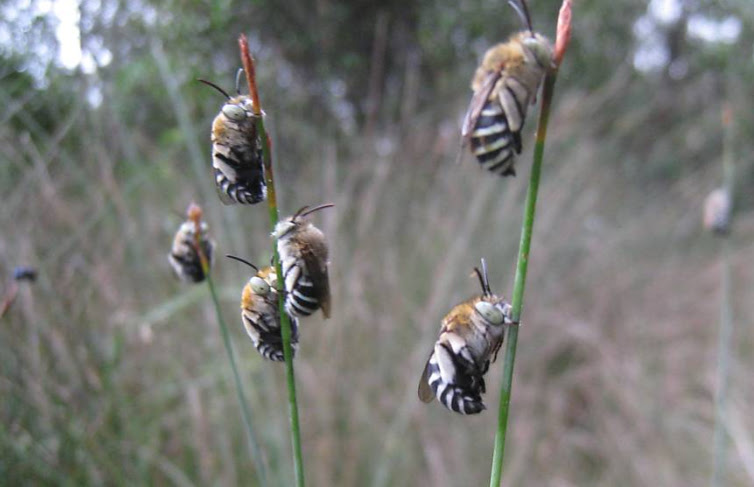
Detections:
[241, 304, 298, 362]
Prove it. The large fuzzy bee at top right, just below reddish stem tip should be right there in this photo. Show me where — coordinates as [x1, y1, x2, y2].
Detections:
[461, 0, 554, 176]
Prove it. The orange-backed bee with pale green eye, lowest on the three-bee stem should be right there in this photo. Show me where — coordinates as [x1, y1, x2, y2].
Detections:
[227, 255, 298, 362]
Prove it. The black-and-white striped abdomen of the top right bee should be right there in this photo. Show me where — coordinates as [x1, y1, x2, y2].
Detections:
[471, 99, 521, 176]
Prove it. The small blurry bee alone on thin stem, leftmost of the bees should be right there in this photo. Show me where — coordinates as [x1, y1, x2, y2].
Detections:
[168, 203, 215, 282]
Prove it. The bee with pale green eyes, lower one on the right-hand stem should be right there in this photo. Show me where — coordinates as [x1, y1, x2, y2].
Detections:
[419, 259, 512, 414]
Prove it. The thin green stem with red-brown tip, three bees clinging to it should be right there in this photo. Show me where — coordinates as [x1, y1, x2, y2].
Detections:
[238, 35, 305, 487]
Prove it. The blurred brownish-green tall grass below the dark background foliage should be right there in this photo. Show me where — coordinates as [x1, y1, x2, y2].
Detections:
[0, 47, 754, 486]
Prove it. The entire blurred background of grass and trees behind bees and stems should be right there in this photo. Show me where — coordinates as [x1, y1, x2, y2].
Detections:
[0, 0, 754, 487]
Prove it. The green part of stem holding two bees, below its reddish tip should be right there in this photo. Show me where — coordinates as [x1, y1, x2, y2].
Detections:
[490, 71, 557, 487]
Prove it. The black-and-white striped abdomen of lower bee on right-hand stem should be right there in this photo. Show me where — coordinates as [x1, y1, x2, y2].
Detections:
[427, 343, 486, 414]
